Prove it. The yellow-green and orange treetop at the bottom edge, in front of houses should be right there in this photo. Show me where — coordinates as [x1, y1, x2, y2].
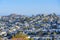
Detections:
[12, 32, 33, 40]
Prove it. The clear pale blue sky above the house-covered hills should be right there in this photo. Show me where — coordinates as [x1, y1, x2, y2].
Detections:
[0, 0, 60, 15]
